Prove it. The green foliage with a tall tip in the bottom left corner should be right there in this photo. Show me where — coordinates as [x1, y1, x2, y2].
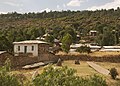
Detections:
[0, 59, 21, 86]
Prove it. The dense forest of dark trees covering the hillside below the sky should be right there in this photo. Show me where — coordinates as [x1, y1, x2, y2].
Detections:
[0, 7, 120, 52]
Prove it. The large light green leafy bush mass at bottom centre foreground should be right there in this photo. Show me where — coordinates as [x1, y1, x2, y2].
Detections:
[33, 65, 107, 86]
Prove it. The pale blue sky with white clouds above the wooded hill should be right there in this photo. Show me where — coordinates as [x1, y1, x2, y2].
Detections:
[0, 0, 120, 13]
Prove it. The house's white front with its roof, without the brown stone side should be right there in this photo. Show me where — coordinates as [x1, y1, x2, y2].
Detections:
[13, 40, 47, 56]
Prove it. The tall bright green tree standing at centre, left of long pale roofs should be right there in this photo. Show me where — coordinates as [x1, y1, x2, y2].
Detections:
[62, 33, 72, 53]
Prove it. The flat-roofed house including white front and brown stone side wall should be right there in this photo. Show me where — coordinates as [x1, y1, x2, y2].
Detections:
[13, 40, 54, 61]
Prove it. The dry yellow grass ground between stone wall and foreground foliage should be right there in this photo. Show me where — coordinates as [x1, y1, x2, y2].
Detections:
[13, 60, 120, 86]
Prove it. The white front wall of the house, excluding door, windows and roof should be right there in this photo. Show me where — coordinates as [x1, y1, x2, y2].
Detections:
[14, 44, 38, 56]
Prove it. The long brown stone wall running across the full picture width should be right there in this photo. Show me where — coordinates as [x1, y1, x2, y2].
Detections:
[0, 52, 120, 67]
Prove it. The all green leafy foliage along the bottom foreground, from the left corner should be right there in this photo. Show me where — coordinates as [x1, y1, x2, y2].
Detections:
[0, 59, 107, 86]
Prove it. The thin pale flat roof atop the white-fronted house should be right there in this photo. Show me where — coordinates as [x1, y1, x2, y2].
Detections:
[13, 40, 47, 44]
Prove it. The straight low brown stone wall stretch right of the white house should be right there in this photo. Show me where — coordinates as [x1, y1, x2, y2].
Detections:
[56, 55, 120, 63]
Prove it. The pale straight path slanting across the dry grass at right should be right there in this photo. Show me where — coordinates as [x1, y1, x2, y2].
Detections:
[87, 62, 110, 75]
